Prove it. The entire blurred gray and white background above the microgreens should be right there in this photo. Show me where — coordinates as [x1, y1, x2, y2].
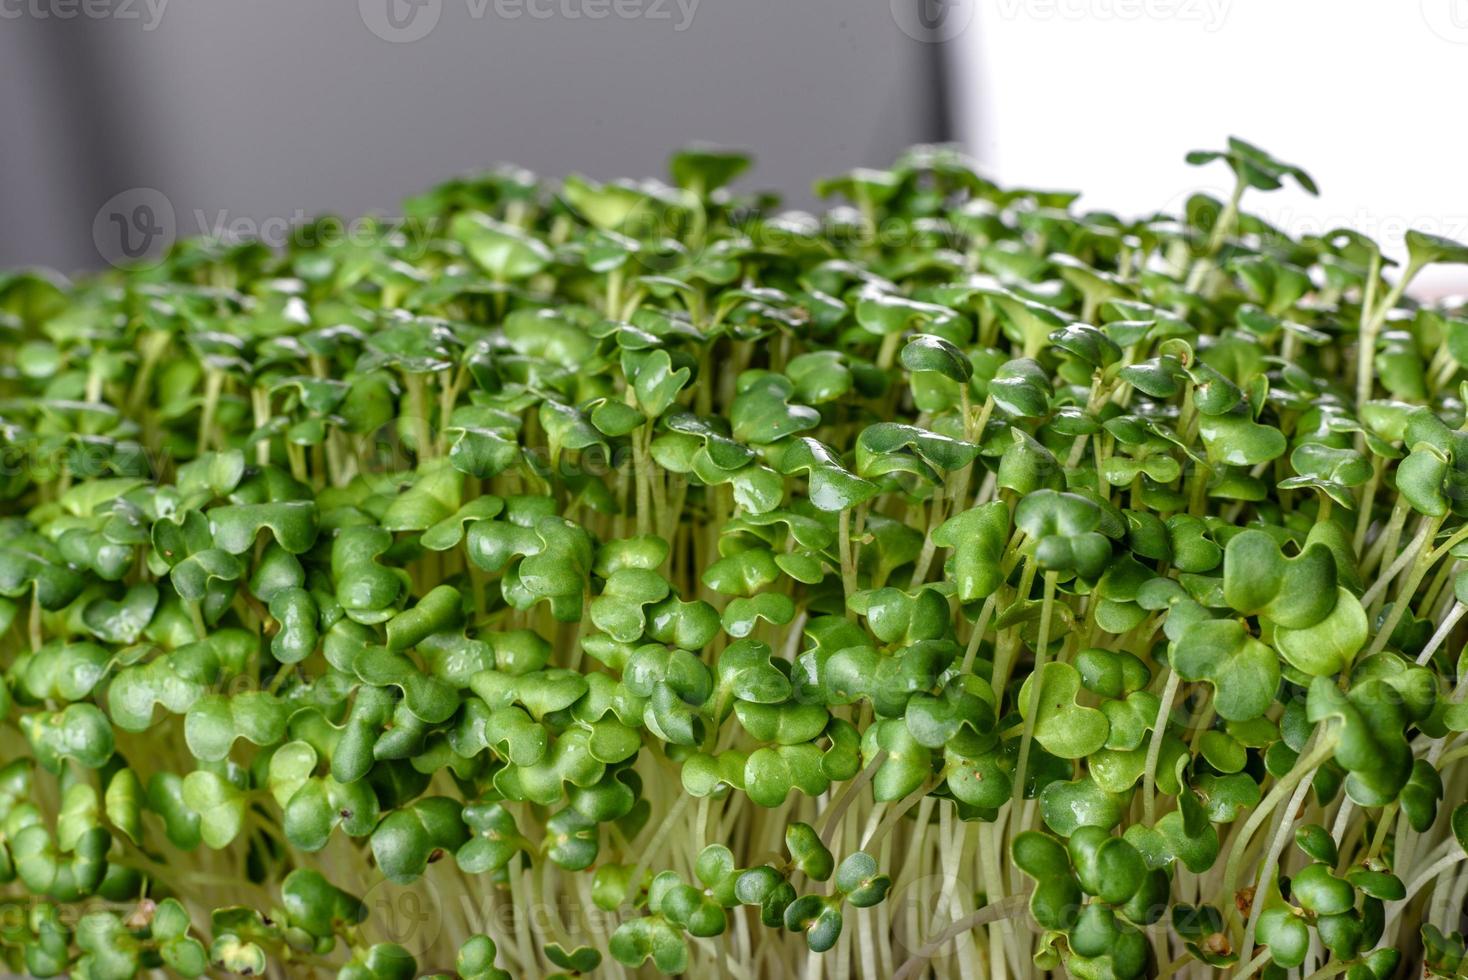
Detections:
[0, 0, 1468, 292]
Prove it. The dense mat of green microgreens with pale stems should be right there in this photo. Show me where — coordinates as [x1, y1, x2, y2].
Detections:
[0, 141, 1468, 980]
